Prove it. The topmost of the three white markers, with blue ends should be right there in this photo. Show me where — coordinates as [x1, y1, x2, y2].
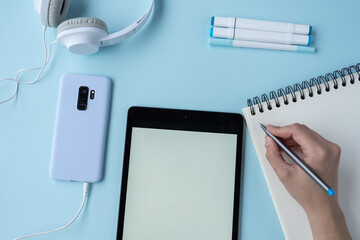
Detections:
[211, 17, 312, 35]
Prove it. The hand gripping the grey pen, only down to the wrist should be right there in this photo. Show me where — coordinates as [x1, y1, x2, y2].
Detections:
[265, 124, 340, 211]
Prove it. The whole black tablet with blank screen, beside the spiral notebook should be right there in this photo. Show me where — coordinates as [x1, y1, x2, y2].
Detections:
[117, 107, 243, 240]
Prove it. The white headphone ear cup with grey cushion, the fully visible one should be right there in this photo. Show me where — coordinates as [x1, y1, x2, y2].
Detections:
[57, 17, 108, 55]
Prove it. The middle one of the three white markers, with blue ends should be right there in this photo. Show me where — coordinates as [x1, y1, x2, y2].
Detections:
[210, 27, 311, 45]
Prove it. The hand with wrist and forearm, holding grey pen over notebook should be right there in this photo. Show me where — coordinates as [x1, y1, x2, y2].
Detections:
[265, 123, 351, 239]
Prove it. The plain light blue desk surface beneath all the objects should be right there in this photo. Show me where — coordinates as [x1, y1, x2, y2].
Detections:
[0, 0, 360, 240]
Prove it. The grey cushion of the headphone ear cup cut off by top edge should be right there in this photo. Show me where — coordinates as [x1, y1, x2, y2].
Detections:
[47, 0, 70, 27]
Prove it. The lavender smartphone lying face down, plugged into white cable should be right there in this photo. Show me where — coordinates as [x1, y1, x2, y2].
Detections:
[50, 74, 111, 183]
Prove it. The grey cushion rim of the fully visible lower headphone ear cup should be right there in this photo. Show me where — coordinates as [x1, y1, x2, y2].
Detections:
[57, 17, 108, 34]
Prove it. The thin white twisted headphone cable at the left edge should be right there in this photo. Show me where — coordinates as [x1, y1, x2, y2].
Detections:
[0, 26, 56, 104]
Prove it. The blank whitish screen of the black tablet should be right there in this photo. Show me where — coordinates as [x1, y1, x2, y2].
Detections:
[123, 128, 237, 240]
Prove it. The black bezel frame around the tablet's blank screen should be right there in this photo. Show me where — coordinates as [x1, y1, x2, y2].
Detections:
[116, 107, 243, 240]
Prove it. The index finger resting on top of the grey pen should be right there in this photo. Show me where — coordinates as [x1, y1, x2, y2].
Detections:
[266, 123, 318, 146]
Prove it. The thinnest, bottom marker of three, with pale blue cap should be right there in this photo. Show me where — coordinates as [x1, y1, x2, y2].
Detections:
[209, 38, 315, 53]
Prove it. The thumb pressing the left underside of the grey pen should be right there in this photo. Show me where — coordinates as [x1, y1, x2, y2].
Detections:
[265, 136, 292, 181]
